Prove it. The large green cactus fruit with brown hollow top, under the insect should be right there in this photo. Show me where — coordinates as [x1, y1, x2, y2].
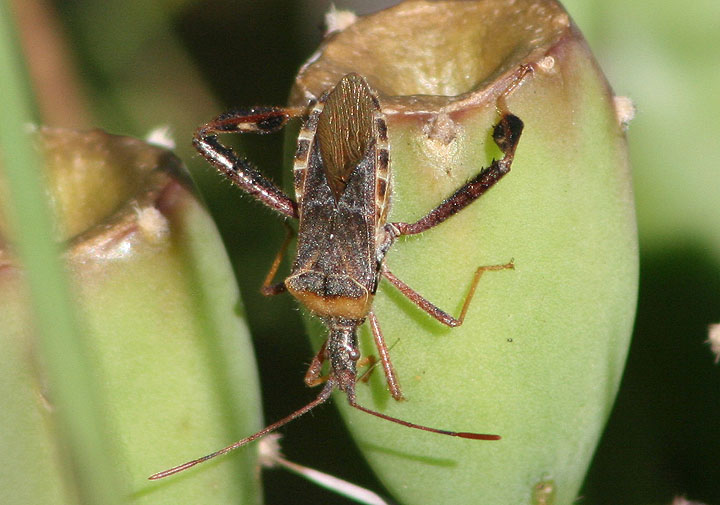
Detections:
[291, 0, 638, 505]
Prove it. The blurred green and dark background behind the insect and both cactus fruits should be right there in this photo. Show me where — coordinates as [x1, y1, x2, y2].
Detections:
[0, 0, 720, 505]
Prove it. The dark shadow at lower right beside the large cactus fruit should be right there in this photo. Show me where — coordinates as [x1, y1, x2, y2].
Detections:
[581, 245, 720, 505]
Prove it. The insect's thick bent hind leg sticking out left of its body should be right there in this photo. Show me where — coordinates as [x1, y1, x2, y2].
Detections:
[193, 107, 302, 218]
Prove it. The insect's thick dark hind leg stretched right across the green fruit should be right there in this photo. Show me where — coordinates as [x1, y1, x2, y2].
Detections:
[386, 113, 523, 237]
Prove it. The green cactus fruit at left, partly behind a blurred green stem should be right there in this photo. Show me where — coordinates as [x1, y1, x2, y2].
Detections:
[0, 129, 262, 505]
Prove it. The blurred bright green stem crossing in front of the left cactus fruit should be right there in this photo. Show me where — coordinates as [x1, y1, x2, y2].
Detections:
[0, 3, 123, 505]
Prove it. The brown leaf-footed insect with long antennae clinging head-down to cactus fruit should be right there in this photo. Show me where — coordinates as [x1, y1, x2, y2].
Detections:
[150, 74, 523, 479]
